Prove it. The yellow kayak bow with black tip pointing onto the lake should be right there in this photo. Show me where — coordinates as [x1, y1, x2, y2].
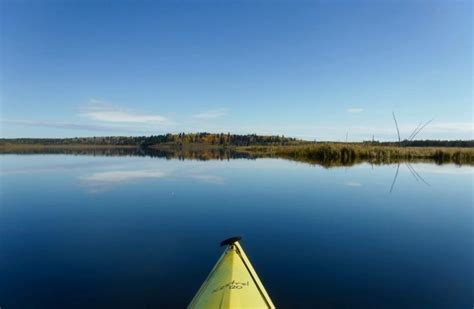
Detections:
[188, 237, 275, 309]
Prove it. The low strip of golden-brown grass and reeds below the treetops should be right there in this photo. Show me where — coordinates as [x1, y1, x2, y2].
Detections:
[0, 142, 474, 166]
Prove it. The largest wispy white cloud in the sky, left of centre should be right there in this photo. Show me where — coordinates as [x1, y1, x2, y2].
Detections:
[79, 99, 171, 125]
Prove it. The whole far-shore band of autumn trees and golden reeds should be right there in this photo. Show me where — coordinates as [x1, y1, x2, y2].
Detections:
[0, 133, 474, 167]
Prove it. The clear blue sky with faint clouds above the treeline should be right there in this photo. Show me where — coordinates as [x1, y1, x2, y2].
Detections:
[0, 0, 474, 140]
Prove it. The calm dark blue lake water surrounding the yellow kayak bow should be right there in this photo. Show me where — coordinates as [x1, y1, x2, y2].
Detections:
[0, 155, 474, 309]
